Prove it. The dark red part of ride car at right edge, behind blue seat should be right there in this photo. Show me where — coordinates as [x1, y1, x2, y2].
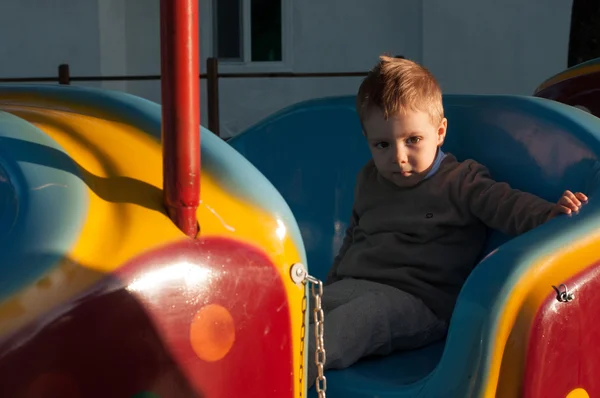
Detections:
[535, 72, 600, 117]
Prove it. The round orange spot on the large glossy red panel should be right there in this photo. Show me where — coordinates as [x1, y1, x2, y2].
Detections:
[190, 304, 235, 362]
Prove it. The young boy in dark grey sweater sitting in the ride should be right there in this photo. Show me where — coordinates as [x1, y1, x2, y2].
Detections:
[308, 57, 587, 386]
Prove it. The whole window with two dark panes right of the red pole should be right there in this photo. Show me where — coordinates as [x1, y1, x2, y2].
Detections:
[213, 0, 286, 63]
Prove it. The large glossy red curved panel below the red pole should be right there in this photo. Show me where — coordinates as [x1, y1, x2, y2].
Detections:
[0, 238, 293, 398]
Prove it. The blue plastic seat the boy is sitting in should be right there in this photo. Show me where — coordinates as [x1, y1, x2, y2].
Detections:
[229, 95, 600, 398]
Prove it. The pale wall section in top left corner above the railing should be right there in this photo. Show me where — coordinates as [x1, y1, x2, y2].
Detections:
[0, 0, 104, 77]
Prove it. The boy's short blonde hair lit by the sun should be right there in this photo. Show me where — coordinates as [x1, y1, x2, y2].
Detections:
[356, 56, 444, 125]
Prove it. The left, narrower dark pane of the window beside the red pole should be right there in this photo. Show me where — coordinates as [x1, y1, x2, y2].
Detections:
[214, 0, 243, 59]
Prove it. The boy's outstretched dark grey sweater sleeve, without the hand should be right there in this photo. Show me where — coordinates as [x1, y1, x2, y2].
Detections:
[460, 162, 554, 235]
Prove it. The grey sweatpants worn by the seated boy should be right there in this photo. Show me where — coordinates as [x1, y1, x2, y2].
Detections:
[307, 279, 447, 388]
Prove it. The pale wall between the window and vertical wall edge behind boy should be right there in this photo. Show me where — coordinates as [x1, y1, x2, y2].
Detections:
[205, 0, 421, 133]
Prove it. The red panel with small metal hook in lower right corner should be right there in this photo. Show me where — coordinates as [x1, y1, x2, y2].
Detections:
[523, 264, 600, 398]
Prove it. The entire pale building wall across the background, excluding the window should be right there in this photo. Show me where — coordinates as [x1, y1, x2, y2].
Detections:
[0, 0, 571, 136]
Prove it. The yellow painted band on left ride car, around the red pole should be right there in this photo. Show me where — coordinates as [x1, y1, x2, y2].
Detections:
[0, 98, 304, 396]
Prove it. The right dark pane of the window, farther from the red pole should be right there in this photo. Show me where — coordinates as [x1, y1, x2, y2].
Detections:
[251, 0, 282, 61]
